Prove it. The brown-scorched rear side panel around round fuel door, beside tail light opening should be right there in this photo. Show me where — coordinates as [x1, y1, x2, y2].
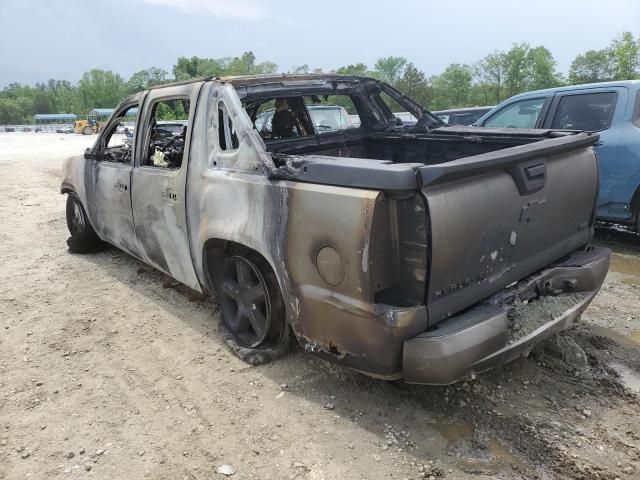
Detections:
[287, 184, 426, 376]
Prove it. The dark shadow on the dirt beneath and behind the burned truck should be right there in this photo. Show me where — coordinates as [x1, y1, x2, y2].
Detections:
[76, 244, 640, 478]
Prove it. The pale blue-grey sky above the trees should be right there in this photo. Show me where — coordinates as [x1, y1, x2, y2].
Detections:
[0, 0, 640, 88]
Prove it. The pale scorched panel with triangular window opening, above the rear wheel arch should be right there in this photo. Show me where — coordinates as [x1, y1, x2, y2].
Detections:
[186, 82, 288, 298]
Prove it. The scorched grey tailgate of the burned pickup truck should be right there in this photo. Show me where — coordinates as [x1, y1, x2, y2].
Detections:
[420, 133, 598, 325]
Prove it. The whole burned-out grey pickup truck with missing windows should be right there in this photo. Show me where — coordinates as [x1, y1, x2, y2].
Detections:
[62, 75, 610, 384]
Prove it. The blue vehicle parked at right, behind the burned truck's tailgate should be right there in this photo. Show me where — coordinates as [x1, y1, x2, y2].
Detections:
[476, 80, 640, 232]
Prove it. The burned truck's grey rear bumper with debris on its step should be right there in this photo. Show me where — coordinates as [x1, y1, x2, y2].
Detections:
[402, 248, 611, 385]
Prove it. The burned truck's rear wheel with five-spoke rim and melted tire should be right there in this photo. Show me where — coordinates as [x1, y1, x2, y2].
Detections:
[216, 253, 289, 365]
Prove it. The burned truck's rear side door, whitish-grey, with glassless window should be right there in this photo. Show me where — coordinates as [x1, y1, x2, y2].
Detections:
[131, 82, 202, 290]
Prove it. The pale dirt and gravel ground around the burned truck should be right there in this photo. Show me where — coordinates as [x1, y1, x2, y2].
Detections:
[0, 133, 640, 480]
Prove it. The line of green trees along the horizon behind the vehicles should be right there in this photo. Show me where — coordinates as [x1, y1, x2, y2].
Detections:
[0, 32, 640, 124]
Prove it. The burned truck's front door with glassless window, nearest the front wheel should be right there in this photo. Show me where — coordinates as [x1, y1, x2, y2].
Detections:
[85, 96, 143, 258]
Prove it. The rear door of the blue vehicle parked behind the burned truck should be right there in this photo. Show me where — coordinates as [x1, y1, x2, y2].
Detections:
[545, 87, 635, 221]
